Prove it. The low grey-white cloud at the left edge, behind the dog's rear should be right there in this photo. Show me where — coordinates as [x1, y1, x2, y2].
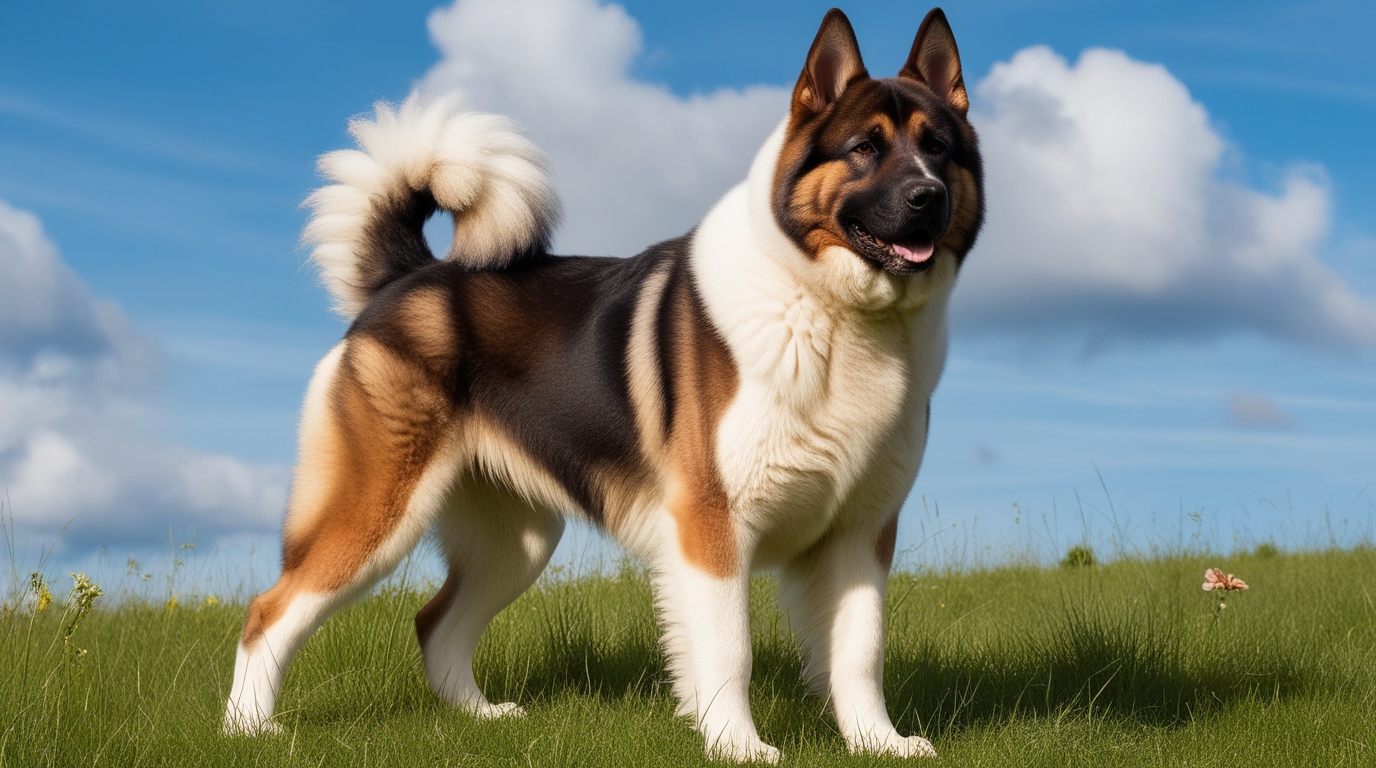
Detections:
[0, 201, 285, 544]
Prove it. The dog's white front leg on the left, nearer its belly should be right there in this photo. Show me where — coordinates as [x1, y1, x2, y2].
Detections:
[654, 526, 779, 762]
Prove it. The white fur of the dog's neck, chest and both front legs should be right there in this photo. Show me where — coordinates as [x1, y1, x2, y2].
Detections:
[668, 119, 956, 757]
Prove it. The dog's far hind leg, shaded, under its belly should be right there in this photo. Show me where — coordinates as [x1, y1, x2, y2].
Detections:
[416, 476, 564, 717]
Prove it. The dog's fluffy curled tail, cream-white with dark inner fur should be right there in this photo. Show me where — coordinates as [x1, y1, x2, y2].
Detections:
[303, 94, 559, 318]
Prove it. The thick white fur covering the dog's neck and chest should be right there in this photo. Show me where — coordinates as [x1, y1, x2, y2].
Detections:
[692, 119, 955, 567]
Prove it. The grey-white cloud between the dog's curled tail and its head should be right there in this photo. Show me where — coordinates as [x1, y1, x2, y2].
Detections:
[421, 0, 787, 256]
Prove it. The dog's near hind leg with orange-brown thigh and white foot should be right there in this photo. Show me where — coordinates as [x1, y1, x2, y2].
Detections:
[224, 339, 457, 734]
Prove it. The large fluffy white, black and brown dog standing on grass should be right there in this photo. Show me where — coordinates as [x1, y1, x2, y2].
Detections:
[226, 10, 982, 760]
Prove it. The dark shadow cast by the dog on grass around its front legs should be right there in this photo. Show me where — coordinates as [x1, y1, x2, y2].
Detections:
[478, 612, 1307, 738]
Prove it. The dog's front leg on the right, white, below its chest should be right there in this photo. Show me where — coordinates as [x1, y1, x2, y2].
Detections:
[782, 518, 936, 757]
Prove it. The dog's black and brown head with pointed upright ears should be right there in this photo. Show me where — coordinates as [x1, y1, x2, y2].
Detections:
[771, 8, 984, 284]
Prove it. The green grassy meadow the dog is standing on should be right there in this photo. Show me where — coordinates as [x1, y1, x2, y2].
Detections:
[0, 548, 1376, 768]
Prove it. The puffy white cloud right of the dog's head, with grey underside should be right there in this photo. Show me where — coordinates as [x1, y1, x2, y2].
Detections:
[955, 47, 1376, 347]
